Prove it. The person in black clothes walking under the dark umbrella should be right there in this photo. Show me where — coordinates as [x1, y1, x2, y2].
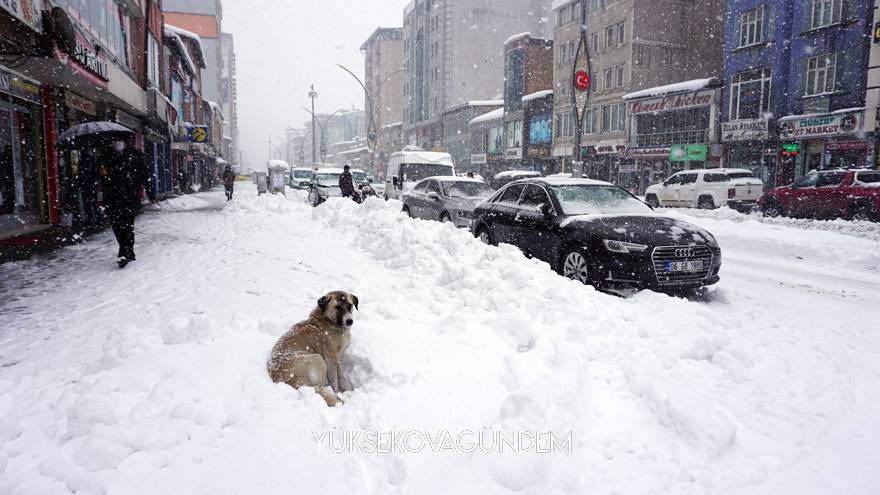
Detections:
[98, 141, 156, 268]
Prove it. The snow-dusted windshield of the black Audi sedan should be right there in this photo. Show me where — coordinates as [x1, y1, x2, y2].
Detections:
[553, 185, 651, 215]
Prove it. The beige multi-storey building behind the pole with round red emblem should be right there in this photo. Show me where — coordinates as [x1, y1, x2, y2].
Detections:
[553, 0, 725, 187]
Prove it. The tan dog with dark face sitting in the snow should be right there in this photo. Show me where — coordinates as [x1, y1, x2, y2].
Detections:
[268, 291, 358, 407]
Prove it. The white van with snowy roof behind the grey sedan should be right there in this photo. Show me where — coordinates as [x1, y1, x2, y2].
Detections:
[385, 146, 455, 199]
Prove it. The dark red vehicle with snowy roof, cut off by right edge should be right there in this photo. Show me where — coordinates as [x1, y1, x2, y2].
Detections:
[758, 170, 880, 222]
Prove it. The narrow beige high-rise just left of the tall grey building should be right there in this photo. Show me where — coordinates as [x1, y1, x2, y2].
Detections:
[361, 28, 404, 167]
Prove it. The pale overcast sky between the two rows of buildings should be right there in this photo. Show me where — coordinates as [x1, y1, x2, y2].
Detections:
[223, 0, 407, 168]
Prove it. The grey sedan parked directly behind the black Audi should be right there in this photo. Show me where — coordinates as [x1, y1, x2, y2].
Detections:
[403, 177, 494, 227]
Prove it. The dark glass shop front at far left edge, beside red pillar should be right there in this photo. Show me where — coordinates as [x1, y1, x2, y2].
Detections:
[0, 66, 49, 239]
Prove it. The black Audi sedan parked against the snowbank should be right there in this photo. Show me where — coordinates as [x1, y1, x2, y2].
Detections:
[472, 177, 721, 292]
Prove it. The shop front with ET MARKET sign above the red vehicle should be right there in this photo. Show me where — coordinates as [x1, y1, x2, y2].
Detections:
[776, 109, 876, 184]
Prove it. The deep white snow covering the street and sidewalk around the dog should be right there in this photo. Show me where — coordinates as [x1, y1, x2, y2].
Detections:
[0, 185, 880, 495]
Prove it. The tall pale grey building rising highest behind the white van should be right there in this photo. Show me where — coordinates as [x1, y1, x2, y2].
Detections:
[403, 0, 551, 150]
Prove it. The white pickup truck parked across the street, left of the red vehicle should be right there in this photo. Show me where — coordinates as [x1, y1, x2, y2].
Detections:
[645, 168, 764, 211]
